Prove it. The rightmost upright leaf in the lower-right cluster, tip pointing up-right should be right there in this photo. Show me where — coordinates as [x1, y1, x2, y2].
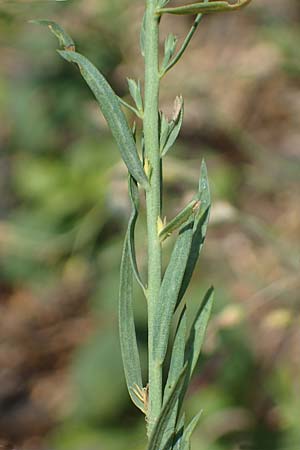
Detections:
[179, 287, 214, 408]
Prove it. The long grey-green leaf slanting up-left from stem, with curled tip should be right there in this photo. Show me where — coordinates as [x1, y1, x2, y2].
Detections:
[58, 50, 149, 189]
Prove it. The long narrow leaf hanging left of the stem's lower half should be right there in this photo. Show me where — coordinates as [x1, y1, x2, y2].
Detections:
[119, 235, 145, 412]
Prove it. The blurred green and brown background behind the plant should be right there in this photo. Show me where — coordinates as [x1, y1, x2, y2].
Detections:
[0, 0, 300, 450]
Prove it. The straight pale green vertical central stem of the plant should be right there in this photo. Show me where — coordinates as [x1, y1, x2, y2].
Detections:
[144, 0, 162, 435]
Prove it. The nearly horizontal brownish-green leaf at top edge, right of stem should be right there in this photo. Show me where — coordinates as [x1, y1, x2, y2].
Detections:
[157, 0, 251, 15]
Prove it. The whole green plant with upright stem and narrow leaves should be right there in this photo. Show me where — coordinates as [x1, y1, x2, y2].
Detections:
[35, 0, 251, 450]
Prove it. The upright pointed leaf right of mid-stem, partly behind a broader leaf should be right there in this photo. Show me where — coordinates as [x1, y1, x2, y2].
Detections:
[176, 161, 211, 306]
